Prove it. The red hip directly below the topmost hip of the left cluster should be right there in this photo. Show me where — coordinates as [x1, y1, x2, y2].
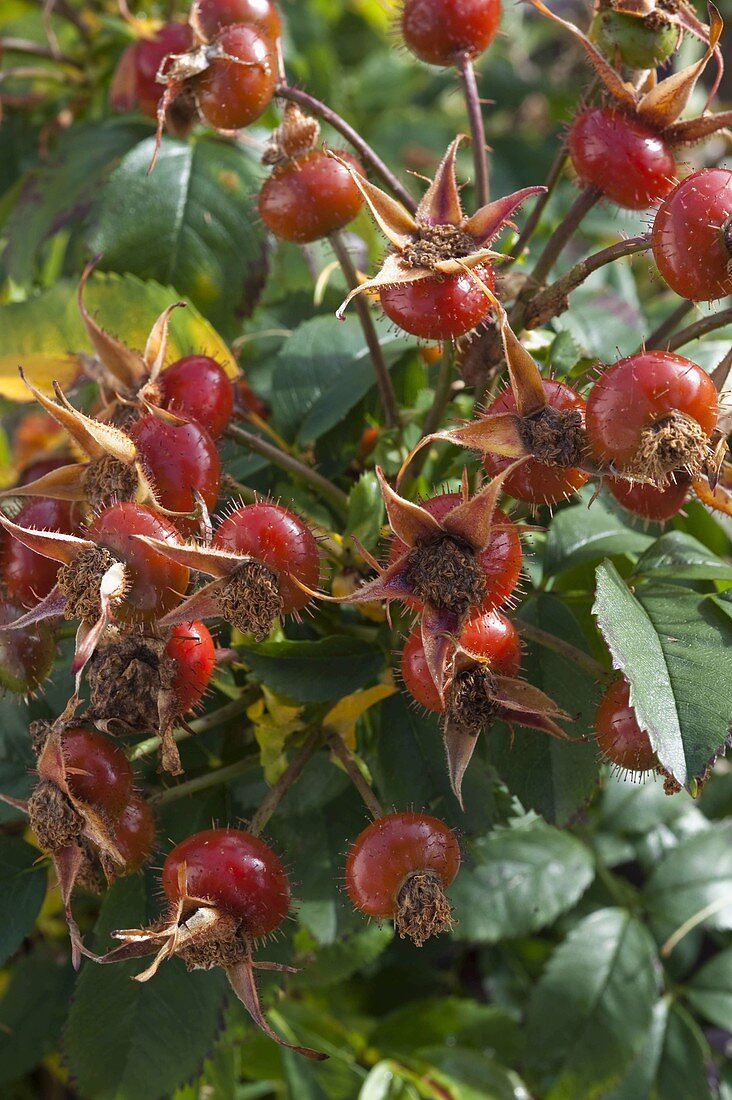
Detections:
[128, 414, 221, 535]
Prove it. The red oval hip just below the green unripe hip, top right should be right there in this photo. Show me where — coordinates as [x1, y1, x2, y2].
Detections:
[569, 107, 676, 210]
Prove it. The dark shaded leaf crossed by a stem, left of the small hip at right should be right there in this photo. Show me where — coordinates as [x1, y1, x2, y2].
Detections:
[488, 595, 599, 825]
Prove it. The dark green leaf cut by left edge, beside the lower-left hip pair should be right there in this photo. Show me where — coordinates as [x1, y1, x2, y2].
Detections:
[0, 836, 46, 965]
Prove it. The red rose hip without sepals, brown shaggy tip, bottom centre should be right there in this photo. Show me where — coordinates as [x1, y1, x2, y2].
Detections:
[346, 813, 460, 947]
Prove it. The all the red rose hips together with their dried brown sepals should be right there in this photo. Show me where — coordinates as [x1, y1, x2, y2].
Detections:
[0, 0, 732, 1057]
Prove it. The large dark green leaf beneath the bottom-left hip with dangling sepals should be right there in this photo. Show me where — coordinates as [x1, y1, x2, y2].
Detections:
[65, 876, 227, 1100]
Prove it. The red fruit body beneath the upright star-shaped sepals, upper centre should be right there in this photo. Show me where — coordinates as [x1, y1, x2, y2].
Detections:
[379, 265, 493, 340]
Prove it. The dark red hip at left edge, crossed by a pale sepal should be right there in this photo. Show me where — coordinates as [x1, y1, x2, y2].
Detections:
[0, 496, 76, 606]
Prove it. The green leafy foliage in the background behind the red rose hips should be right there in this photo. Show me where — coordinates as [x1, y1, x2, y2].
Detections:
[0, 0, 732, 1100]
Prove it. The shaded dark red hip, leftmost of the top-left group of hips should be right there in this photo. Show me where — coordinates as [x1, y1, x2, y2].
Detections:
[109, 23, 193, 119]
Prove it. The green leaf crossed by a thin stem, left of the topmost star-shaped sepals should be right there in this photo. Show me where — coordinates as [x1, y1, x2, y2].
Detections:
[270, 315, 409, 446]
